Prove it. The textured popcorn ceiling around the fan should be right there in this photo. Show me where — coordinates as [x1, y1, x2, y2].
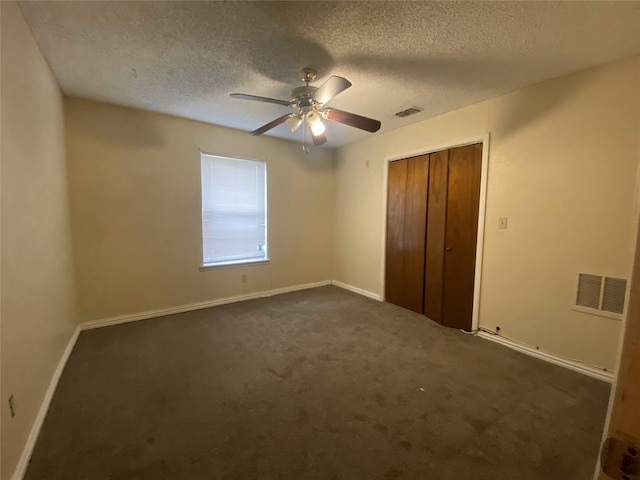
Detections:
[20, 1, 640, 147]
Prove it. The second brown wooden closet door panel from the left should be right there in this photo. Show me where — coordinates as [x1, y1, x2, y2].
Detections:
[402, 155, 429, 313]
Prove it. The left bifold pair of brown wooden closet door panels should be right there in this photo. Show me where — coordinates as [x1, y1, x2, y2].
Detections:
[385, 155, 429, 313]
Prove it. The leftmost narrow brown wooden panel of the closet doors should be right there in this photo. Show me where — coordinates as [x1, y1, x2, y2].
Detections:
[385, 160, 409, 305]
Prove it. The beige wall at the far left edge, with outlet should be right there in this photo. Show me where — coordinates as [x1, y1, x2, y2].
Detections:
[1, 2, 77, 479]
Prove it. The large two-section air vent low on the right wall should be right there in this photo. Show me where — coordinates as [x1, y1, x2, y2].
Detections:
[573, 273, 627, 319]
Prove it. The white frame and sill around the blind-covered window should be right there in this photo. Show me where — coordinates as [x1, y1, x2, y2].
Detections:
[199, 151, 271, 270]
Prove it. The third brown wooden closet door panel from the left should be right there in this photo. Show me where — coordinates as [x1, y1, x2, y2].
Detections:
[424, 150, 449, 323]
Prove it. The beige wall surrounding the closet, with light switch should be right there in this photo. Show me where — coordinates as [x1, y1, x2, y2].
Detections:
[335, 57, 640, 369]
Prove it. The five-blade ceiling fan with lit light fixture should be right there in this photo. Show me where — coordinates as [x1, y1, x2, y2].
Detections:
[231, 68, 381, 148]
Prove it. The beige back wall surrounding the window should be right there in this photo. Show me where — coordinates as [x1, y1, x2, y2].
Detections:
[65, 98, 335, 321]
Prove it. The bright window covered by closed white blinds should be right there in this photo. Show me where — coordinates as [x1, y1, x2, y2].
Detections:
[200, 153, 267, 266]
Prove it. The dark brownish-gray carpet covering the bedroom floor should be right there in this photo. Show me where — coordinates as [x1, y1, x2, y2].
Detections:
[26, 287, 609, 480]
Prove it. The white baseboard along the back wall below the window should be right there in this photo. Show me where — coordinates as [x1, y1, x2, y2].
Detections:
[80, 280, 331, 330]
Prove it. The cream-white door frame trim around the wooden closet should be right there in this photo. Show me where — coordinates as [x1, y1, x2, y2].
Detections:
[380, 133, 491, 330]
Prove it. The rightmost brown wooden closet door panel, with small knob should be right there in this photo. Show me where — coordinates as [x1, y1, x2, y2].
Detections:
[442, 144, 482, 330]
